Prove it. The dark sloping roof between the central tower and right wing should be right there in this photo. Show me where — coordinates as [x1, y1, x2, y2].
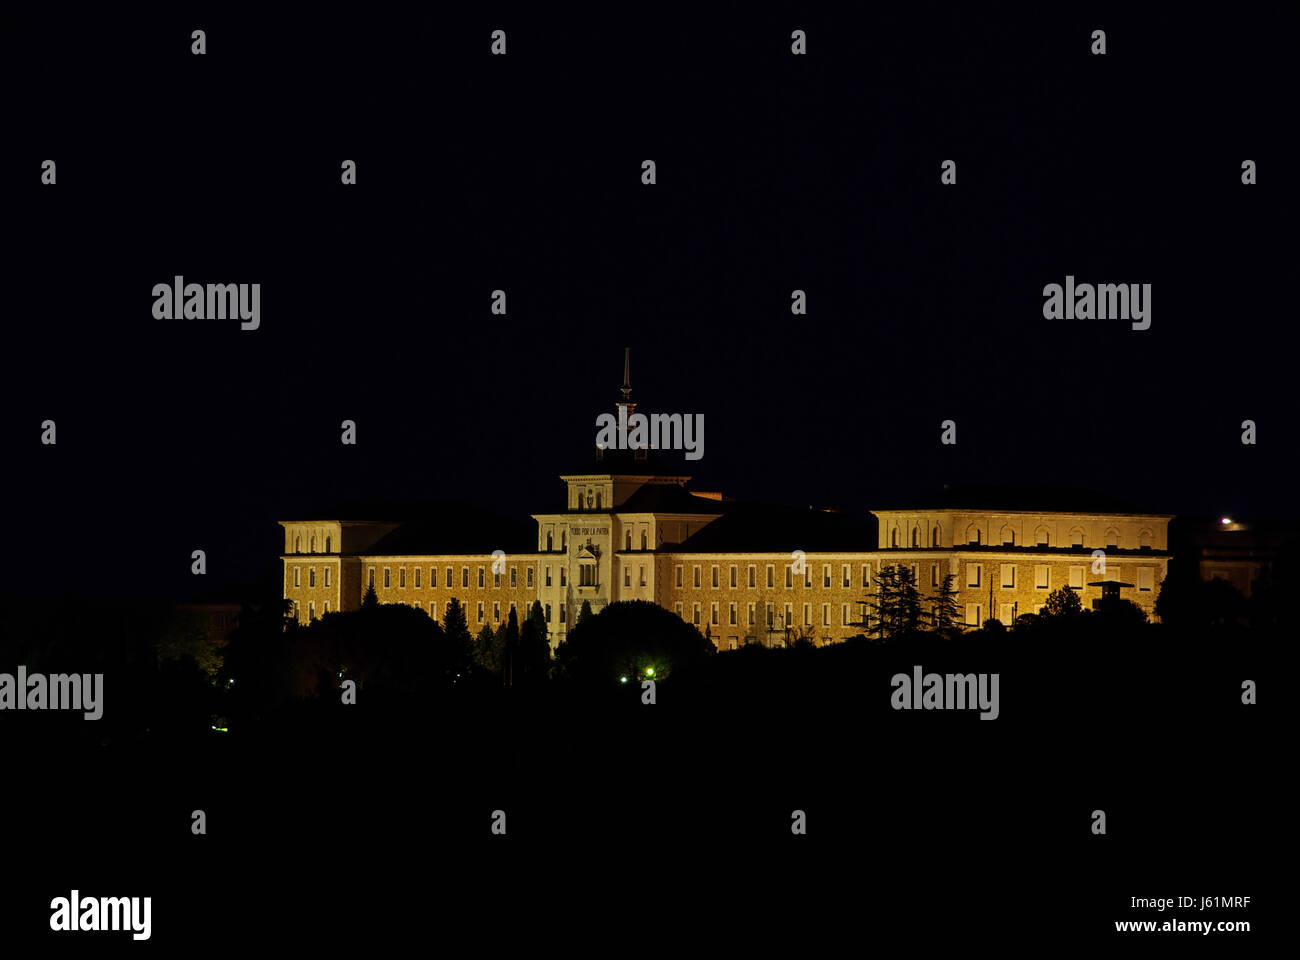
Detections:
[675, 501, 876, 553]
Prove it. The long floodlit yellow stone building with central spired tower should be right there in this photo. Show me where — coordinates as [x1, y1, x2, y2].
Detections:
[281, 364, 1173, 649]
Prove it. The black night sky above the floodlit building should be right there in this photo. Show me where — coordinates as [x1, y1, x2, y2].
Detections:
[0, 4, 1297, 593]
